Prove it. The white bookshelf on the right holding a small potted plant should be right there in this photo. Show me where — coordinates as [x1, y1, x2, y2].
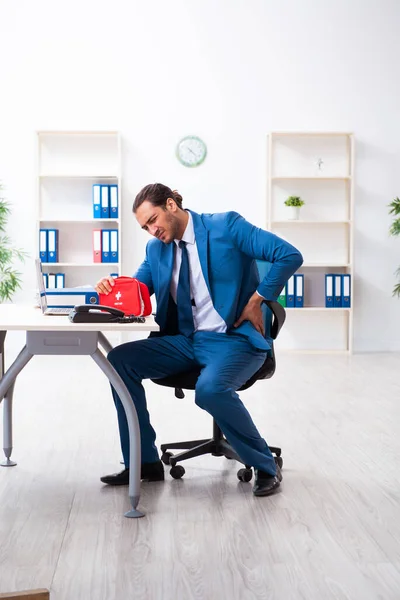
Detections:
[267, 132, 354, 352]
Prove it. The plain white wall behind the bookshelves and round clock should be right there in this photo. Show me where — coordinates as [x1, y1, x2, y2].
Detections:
[0, 0, 400, 350]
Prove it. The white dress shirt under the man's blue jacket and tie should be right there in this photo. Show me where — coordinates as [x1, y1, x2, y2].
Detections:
[170, 212, 226, 333]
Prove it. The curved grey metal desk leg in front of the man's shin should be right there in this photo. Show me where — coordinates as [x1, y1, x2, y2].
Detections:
[91, 349, 144, 518]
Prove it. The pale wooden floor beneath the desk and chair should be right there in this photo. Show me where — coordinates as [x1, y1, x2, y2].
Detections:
[0, 336, 400, 600]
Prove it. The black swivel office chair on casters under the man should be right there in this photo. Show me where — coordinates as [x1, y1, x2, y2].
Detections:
[152, 300, 286, 481]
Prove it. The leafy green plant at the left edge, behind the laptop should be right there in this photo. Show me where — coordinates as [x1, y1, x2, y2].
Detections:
[0, 183, 27, 302]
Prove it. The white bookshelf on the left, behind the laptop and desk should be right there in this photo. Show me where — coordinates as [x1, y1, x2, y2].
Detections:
[36, 131, 122, 287]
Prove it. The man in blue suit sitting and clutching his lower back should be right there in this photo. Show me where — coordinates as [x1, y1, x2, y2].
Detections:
[96, 183, 303, 496]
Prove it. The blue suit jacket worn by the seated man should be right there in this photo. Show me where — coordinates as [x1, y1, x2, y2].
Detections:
[134, 211, 303, 350]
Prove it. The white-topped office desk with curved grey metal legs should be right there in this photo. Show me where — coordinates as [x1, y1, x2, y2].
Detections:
[0, 304, 159, 517]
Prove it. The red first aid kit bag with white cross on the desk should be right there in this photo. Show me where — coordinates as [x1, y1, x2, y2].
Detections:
[99, 277, 151, 317]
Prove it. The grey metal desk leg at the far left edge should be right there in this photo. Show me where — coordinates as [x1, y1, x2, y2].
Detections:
[0, 346, 33, 467]
